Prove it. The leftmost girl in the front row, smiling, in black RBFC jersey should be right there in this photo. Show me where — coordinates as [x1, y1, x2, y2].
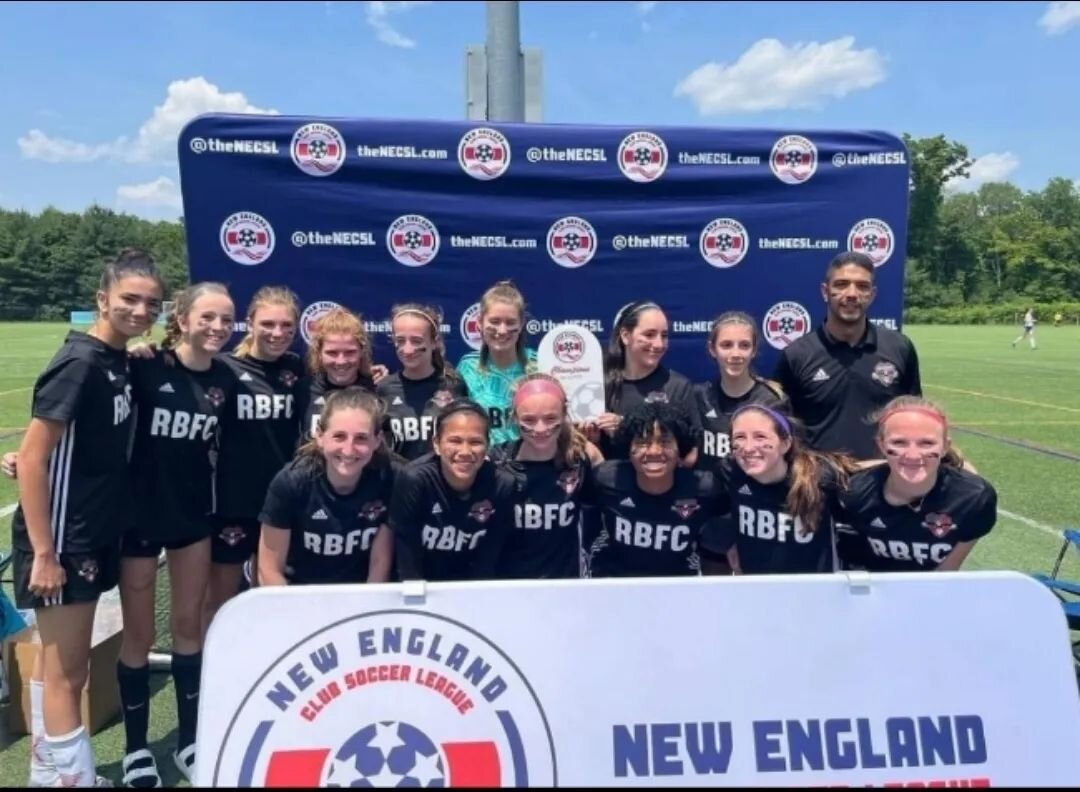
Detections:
[258, 387, 394, 586]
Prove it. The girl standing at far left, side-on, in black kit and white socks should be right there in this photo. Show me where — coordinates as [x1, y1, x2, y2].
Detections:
[11, 250, 164, 787]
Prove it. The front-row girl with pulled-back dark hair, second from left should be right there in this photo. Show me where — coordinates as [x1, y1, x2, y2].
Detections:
[390, 399, 516, 580]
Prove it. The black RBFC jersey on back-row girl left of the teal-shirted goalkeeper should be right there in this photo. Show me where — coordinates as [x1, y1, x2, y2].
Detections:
[377, 372, 469, 459]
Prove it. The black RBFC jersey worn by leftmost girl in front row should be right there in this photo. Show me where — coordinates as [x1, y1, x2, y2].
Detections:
[259, 460, 394, 585]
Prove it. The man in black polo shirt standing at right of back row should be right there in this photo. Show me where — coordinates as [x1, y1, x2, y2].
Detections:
[773, 252, 922, 460]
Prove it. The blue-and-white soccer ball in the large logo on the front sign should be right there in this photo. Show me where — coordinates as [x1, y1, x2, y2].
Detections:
[323, 721, 447, 788]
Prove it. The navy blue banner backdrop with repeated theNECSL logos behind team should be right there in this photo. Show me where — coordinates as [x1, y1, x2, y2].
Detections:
[179, 115, 909, 380]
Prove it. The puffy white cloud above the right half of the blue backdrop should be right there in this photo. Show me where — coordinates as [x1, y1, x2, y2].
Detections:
[675, 36, 885, 116]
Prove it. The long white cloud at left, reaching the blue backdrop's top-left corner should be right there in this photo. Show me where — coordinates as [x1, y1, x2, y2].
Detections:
[18, 77, 278, 162]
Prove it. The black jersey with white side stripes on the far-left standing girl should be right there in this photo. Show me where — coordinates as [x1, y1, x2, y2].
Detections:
[11, 331, 133, 553]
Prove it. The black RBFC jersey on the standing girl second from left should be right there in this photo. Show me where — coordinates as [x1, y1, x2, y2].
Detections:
[131, 351, 237, 542]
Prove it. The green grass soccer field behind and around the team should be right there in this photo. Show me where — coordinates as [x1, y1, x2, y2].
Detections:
[0, 323, 1080, 787]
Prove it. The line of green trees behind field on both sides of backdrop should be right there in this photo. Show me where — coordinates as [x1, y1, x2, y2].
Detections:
[0, 134, 1080, 323]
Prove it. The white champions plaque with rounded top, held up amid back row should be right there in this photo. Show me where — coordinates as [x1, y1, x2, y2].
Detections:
[537, 324, 605, 422]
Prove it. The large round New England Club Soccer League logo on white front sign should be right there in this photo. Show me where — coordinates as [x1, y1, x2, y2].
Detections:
[207, 609, 557, 788]
